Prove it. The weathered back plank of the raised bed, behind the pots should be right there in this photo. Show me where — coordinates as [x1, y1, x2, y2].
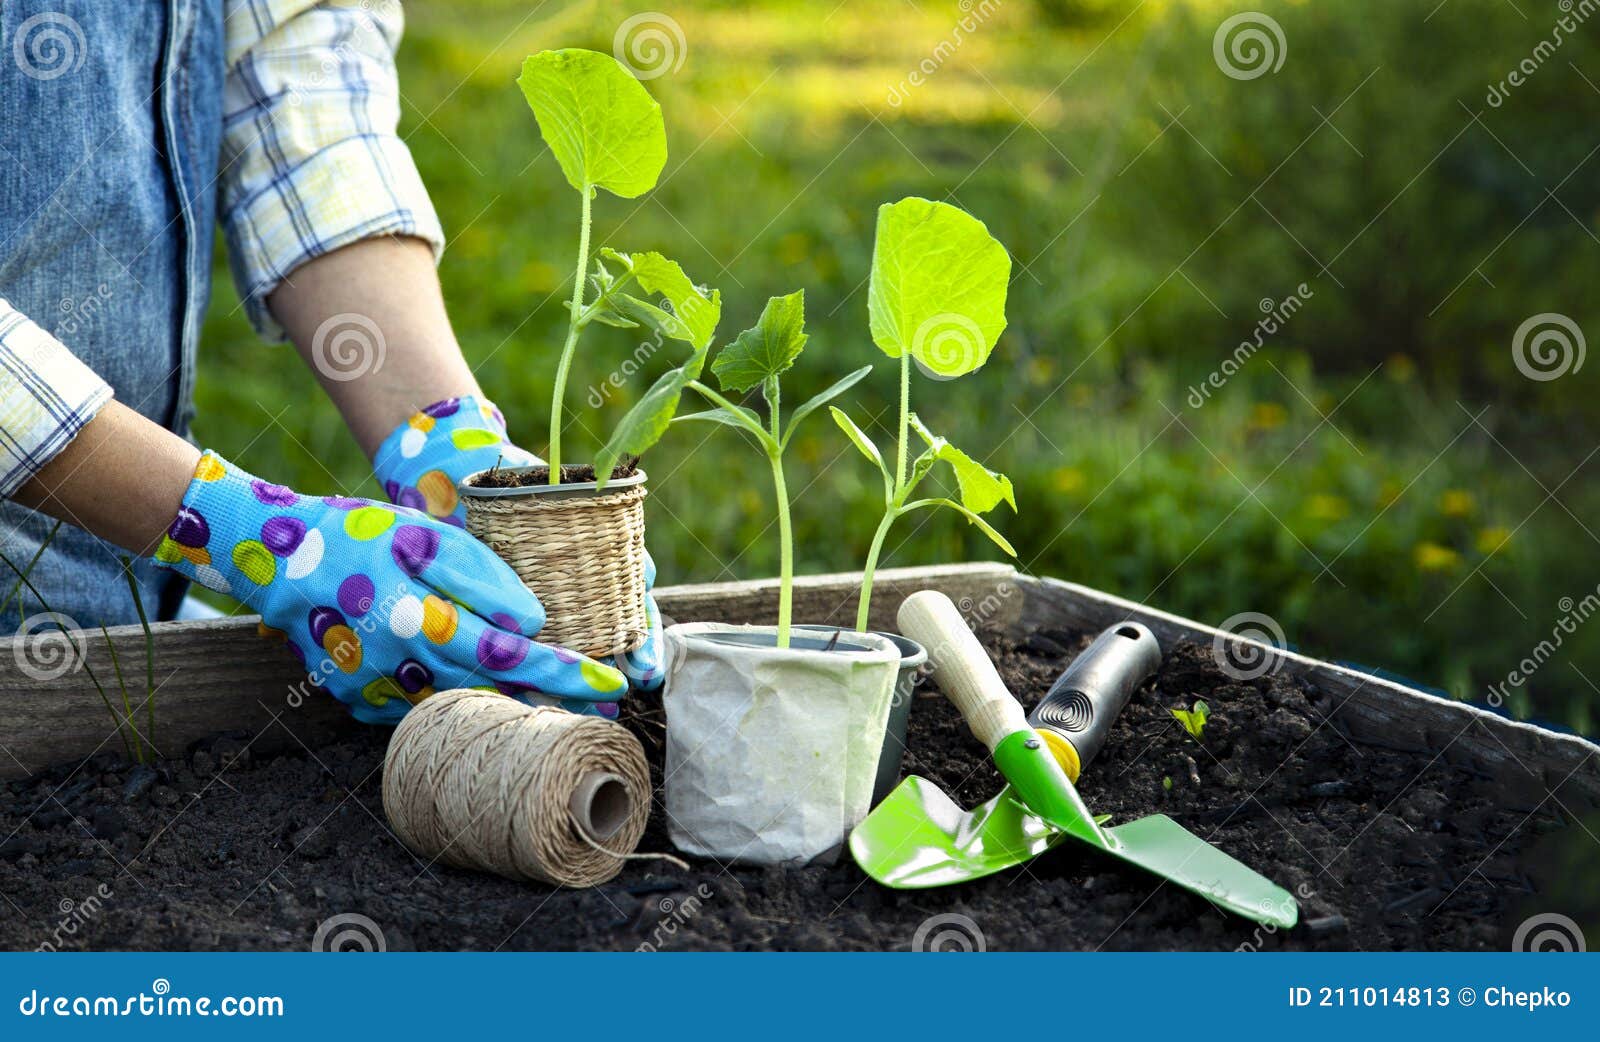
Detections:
[0, 563, 1021, 778]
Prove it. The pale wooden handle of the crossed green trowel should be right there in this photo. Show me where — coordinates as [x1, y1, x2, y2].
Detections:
[899, 589, 1027, 751]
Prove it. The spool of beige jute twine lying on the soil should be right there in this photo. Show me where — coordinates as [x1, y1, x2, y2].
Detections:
[384, 690, 659, 887]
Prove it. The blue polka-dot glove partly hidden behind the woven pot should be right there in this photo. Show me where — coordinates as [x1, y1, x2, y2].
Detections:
[373, 395, 666, 691]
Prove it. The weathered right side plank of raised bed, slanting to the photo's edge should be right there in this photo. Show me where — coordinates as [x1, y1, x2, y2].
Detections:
[1016, 578, 1600, 813]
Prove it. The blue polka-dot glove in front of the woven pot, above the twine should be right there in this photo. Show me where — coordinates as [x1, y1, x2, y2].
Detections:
[155, 451, 627, 723]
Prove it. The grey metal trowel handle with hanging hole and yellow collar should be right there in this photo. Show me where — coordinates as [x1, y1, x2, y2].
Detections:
[1027, 623, 1162, 781]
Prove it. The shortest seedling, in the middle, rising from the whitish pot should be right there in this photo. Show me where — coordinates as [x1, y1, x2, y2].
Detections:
[674, 290, 872, 648]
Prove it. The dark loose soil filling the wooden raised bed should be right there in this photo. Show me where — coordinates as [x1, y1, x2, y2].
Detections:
[0, 631, 1576, 949]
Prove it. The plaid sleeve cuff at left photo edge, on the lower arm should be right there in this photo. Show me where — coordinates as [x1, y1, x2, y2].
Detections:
[0, 298, 110, 496]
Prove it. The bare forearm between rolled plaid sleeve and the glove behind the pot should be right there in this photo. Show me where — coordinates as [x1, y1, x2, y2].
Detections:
[267, 237, 478, 456]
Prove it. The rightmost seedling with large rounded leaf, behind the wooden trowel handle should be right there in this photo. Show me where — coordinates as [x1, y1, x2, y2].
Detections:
[830, 197, 1016, 631]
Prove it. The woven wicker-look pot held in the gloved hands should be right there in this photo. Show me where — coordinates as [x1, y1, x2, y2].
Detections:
[459, 467, 650, 658]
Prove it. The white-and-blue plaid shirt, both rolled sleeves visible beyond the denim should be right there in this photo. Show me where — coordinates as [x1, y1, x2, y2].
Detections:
[0, 0, 445, 496]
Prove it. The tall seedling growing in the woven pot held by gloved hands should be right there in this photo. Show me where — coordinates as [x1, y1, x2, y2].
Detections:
[517, 50, 722, 488]
